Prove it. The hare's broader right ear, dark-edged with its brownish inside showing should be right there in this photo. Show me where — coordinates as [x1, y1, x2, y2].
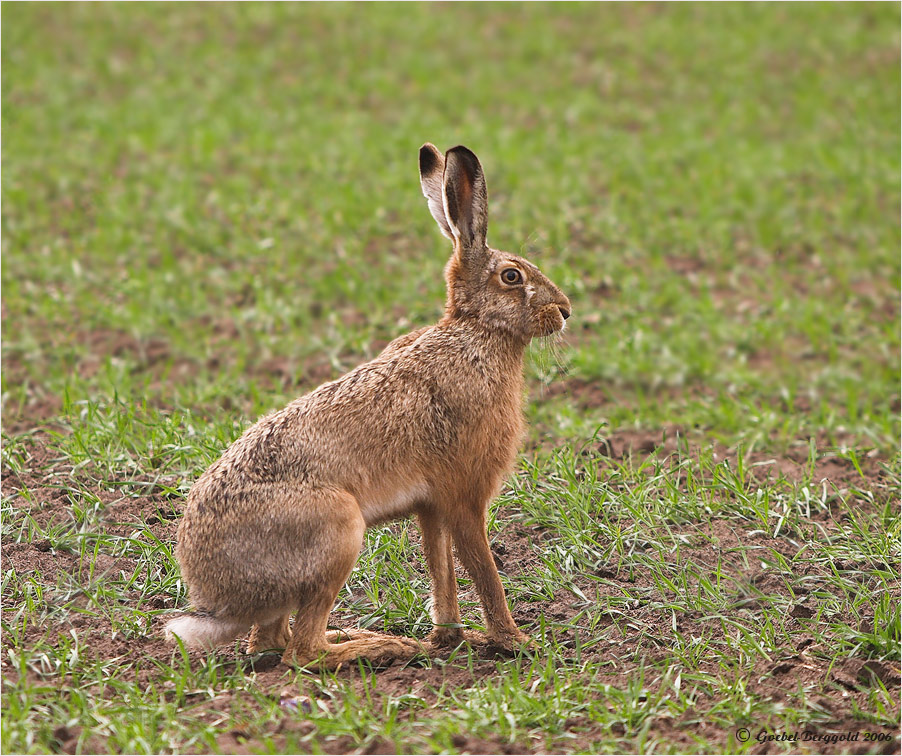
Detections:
[444, 146, 489, 259]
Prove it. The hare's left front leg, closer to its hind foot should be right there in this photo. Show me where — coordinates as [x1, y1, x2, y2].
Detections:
[419, 511, 463, 646]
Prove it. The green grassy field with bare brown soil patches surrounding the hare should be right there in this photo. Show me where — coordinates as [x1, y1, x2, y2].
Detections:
[0, 4, 900, 753]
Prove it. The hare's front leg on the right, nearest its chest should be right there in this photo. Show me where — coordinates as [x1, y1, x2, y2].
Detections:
[453, 507, 531, 650]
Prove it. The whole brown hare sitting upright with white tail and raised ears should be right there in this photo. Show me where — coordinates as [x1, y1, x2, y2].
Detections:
[166, 143, 570, 667]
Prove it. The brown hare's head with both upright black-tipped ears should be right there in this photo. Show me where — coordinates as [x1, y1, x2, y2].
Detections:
[420, 142, 570, 341]
